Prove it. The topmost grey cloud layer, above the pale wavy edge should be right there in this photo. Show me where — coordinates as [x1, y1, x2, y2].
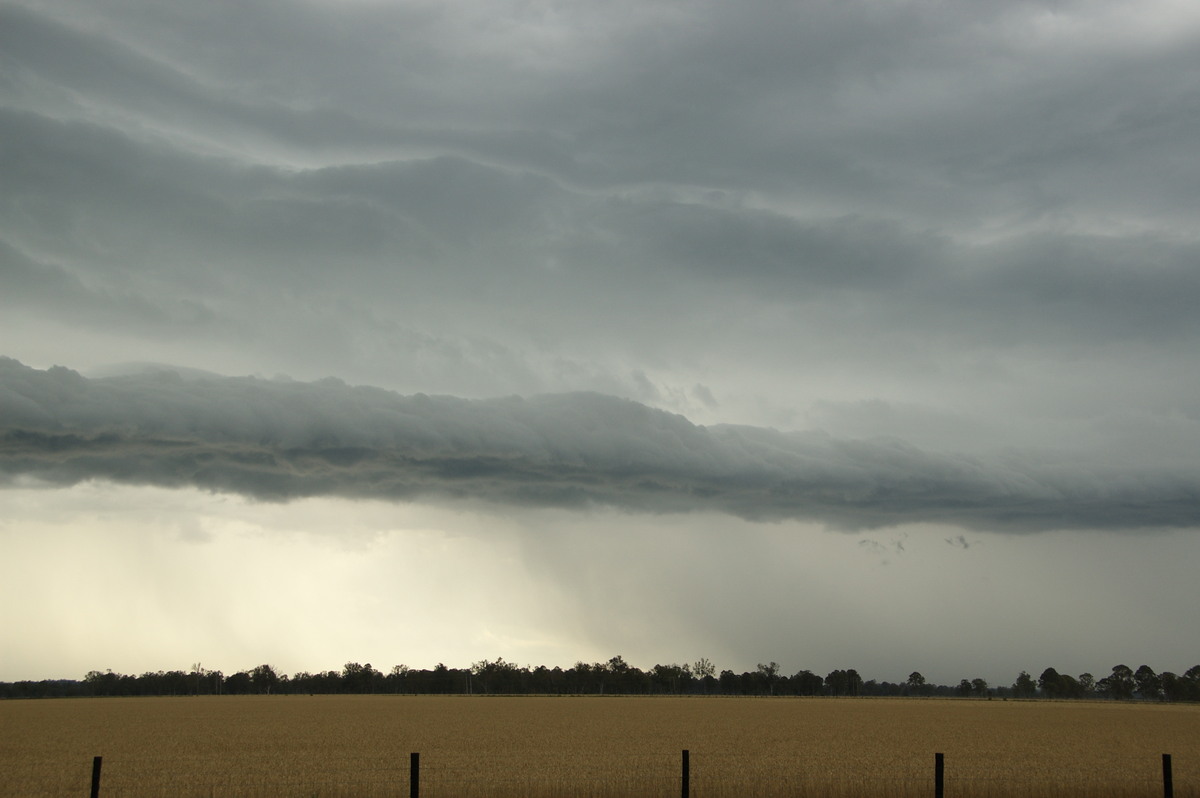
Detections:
[10, 2, 1198, 211]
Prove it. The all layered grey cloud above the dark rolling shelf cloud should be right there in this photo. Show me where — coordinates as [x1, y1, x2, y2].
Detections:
[0, 1, 1200, 429]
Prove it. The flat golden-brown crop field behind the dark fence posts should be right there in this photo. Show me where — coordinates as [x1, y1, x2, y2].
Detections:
[0, 696, 1200, 798]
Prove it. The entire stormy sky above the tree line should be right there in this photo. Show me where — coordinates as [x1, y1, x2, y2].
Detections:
[0, 0, 1200, 684]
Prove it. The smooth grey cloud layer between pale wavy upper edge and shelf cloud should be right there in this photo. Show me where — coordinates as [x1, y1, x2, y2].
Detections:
[9, 88, 1200, 412]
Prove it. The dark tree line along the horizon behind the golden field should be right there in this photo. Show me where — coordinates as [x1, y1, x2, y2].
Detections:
[0, 655, 1200, 701]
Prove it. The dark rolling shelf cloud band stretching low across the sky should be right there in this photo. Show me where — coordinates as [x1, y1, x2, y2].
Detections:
[0, 359, 1200, 532]
